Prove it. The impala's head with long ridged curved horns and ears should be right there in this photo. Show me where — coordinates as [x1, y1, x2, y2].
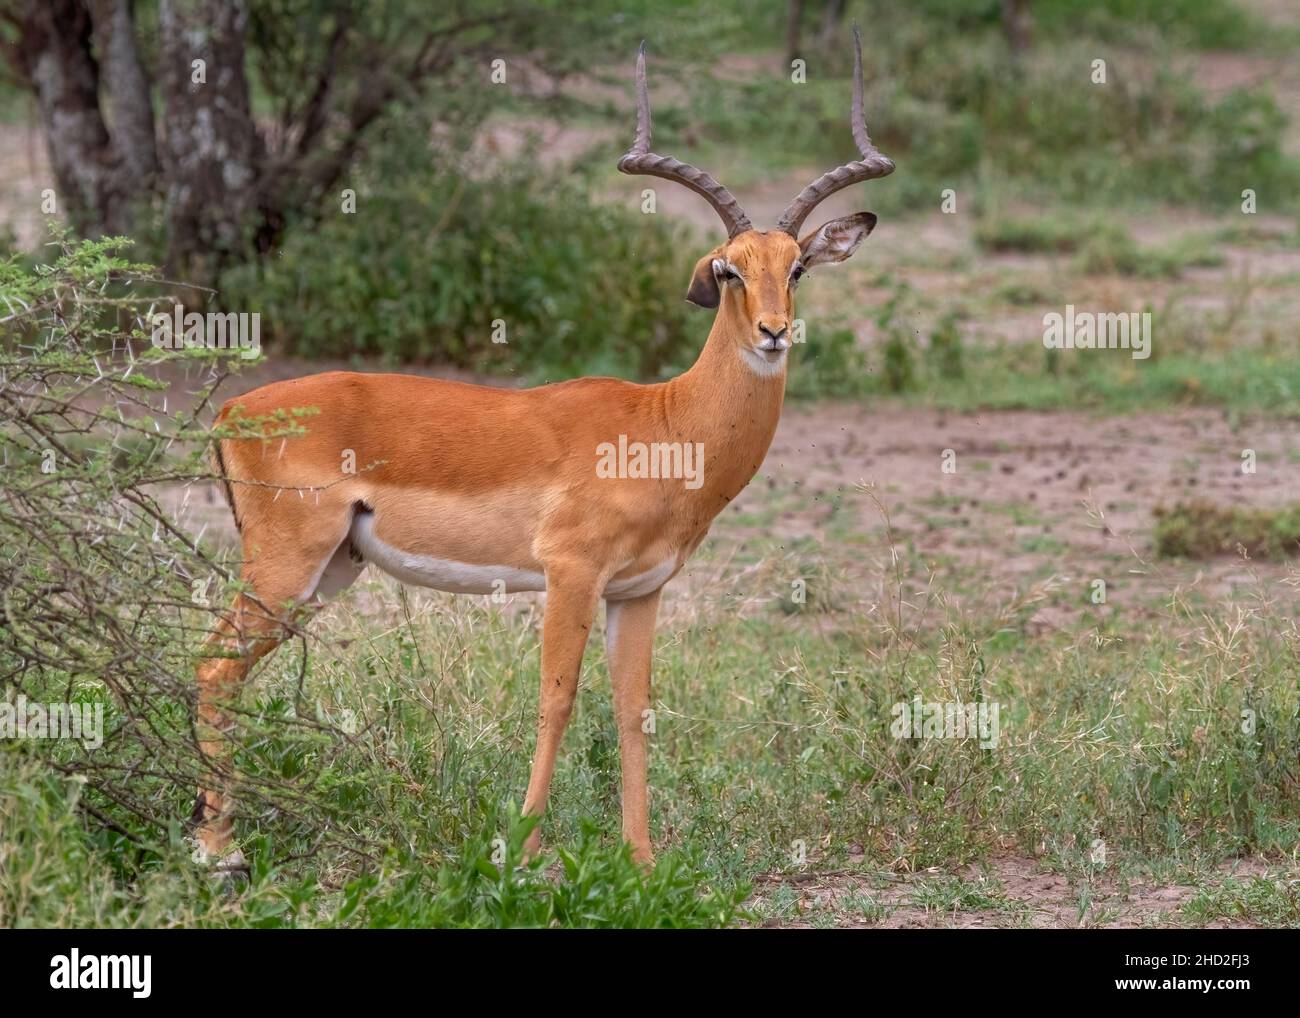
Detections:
[619, 26, 894, 373]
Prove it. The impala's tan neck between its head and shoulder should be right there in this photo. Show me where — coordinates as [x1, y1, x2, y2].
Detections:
[664, 300, 789, 512]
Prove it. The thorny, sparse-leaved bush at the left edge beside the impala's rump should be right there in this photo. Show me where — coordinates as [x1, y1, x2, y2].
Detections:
[0, 228, 371, 894]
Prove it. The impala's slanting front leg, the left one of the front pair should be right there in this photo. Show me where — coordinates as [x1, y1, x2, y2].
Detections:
[524, 572, 598, 858]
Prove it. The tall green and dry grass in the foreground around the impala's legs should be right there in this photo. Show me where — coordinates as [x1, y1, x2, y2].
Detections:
[0, 522, 1300, 926]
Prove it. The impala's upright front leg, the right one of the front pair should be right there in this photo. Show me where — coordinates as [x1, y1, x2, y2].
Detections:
[605, 590, 659, 865]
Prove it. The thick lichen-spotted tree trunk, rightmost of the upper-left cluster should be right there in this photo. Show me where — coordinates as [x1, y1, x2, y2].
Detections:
[159, 0, 261, 286]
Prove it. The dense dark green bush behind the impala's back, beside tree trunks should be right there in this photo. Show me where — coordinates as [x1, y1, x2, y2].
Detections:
[221, 131, 707, 380]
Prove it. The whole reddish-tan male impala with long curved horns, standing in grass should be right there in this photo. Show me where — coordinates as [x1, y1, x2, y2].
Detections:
[195, 29, 893, 867]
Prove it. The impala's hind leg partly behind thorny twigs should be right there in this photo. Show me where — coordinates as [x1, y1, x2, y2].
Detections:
[191, 540, 363, 870]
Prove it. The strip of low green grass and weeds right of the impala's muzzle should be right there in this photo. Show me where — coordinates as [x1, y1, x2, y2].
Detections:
[789, 270, 1300, 416]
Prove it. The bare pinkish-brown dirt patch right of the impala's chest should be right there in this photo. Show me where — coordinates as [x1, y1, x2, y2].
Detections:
[759, 406, 1300, 625]
